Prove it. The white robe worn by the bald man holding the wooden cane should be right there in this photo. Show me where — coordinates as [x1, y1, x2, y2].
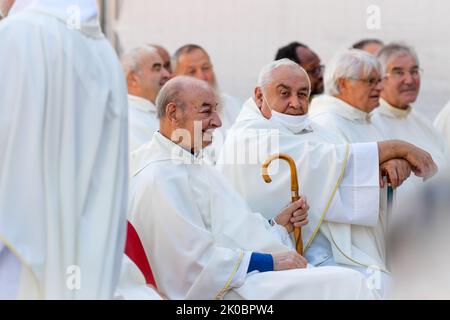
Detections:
[130, 133, 377, 300]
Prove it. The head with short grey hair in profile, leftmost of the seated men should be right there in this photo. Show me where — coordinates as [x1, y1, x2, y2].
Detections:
[121, 46, 170, 103]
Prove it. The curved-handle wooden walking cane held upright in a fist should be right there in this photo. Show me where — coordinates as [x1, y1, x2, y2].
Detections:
[262, 153, 303, 254]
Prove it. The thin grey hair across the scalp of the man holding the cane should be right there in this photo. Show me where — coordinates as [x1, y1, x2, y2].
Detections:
[156, 76, 213, 119]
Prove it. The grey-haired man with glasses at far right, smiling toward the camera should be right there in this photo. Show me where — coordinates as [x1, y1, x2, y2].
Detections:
[371, 43, 450, 201]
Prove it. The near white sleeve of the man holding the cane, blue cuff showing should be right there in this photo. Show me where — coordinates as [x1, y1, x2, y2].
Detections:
[131, 166, 249, 299]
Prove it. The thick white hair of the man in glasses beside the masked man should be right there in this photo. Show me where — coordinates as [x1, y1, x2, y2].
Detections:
[324, 49, 382, 96]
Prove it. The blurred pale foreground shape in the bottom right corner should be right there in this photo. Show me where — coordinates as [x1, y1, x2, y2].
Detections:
[389, 174, 450, 300]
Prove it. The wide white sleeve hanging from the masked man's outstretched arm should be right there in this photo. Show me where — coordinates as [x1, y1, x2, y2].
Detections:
[326, 143, 380, 227]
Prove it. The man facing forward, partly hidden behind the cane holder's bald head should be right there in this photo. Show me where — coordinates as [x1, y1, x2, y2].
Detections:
[172, 44, 242, 163]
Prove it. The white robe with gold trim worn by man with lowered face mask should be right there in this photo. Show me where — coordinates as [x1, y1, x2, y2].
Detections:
[216, 99, 383, 282]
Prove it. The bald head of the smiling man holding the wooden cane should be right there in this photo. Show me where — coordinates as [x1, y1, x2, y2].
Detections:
[156, 76, 222, 152]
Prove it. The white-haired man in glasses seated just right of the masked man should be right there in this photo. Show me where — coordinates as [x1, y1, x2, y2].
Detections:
[310, 49, 438, 284]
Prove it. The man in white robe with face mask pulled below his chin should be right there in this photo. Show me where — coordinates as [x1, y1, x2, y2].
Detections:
[217, 59, 434, 294]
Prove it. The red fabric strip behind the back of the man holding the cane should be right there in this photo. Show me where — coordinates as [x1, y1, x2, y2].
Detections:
[125, 221, 157, 288]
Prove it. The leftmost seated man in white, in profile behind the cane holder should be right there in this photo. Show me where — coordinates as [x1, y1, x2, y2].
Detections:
[121, 45, 170, 153]
